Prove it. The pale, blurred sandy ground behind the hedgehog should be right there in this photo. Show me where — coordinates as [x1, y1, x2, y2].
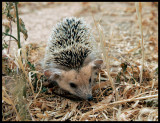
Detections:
[7, 2, 158, 69]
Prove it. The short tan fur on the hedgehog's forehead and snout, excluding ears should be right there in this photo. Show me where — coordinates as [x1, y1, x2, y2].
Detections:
[57, 64, 92, 99]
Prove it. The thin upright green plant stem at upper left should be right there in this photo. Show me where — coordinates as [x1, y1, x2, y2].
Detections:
[15, 2, 21, 48]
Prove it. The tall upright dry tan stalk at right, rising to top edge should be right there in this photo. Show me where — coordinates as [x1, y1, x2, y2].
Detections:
[135, 2, 144, 84]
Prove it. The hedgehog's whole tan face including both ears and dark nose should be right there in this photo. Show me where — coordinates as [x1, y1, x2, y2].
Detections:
[45, 61, 101, 100]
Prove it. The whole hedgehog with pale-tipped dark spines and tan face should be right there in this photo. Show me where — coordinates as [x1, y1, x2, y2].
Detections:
[44, 17, 103, 100]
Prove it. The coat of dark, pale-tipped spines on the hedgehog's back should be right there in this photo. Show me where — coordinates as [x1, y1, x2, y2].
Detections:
[45, 17, 97, 69]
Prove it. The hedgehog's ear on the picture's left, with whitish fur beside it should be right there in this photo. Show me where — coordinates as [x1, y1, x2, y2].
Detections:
[44, 69, 62, 80]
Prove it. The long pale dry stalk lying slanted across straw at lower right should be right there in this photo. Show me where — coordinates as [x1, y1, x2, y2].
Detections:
[80, 94, 158, 120]
